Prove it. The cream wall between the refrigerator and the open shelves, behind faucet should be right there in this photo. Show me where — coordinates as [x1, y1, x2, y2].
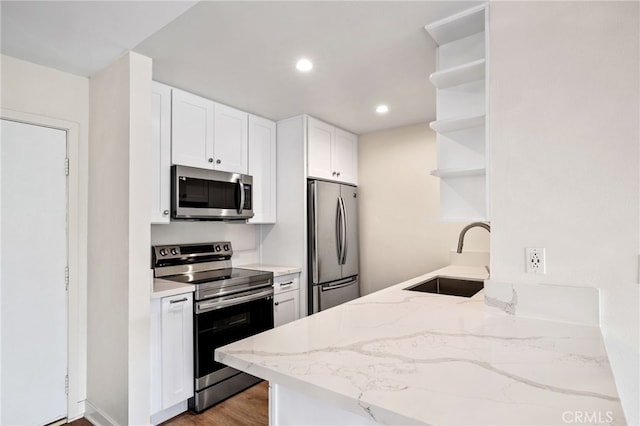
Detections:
[358, 123, 489, 294]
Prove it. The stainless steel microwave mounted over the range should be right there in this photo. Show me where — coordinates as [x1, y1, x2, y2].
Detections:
[171, 166, 253, 220]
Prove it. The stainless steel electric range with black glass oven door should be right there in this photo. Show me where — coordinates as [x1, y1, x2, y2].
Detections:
[152, 241, 273, 413]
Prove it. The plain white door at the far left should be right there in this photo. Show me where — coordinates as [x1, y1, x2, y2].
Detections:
[0, 120, 67, 425]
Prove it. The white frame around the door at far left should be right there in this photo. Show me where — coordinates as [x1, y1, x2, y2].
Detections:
[0, 108, 87, 421]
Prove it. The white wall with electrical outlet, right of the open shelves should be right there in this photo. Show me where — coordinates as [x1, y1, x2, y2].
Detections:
[490, 2, 640, 424]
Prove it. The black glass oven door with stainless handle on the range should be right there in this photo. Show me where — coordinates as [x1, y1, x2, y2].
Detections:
[194, 287, 273, 391]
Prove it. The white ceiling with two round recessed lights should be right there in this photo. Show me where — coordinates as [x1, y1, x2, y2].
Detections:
[1, 1, 479, 134]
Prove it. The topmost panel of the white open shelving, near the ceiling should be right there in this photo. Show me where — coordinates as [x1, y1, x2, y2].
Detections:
[424, 5, 486, 46]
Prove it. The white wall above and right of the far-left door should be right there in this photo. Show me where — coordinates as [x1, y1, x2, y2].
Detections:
[0, 55, 89, 419]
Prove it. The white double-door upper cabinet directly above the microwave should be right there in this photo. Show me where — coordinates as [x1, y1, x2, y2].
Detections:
[171, 89, 249, 174]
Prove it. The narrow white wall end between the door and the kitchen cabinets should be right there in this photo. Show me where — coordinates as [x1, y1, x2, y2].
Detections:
[87, 53, 151, 425]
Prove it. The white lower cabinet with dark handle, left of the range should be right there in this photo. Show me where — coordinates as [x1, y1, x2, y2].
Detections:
[151, 293, 194, 424]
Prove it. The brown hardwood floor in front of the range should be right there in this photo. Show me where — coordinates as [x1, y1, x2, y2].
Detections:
[69, 382, 269, 426]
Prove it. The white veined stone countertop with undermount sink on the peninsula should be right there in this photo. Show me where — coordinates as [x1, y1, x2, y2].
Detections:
[216, 265, 625, 425]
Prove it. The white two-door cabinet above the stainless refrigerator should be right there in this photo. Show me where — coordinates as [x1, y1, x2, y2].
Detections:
[307, 117, 358, 185]
